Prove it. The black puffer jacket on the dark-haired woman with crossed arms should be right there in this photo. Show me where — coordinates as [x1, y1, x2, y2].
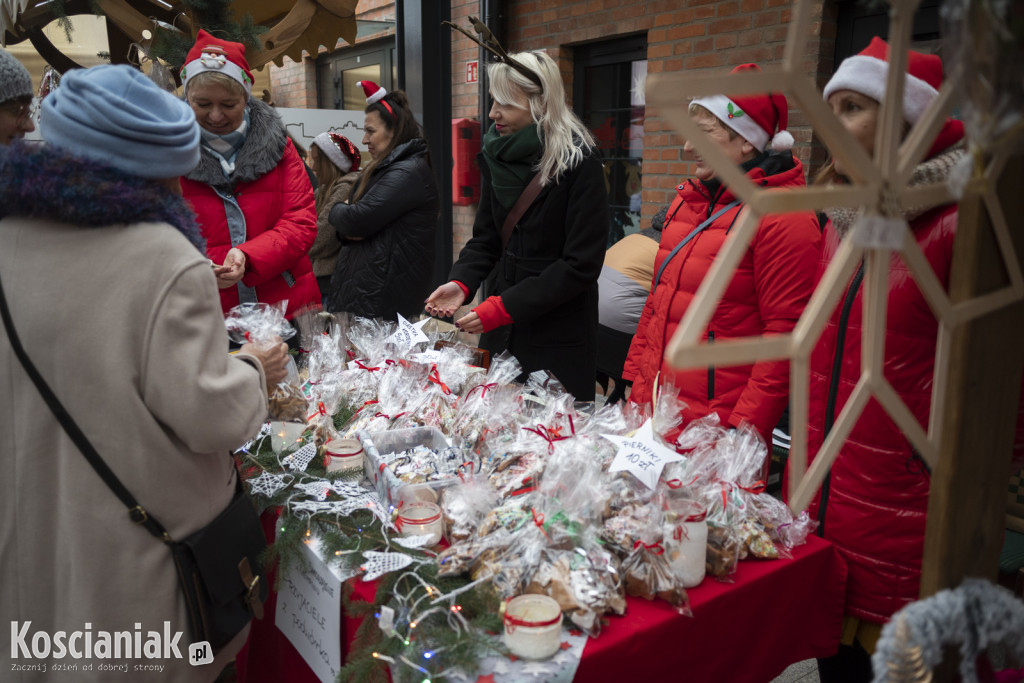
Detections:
[328, 138, 440, 321]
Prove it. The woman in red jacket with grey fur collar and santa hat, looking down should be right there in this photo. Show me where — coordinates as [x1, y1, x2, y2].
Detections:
[181, 30, 321, 317]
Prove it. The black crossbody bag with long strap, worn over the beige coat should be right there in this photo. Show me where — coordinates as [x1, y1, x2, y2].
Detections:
[0, 270, 267, 652]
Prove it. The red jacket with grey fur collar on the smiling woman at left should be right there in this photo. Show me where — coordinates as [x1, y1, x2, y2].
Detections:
[181, 99, 321, 317]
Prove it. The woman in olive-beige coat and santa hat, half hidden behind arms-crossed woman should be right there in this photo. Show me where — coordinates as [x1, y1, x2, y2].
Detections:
[309, 133, 360, 305]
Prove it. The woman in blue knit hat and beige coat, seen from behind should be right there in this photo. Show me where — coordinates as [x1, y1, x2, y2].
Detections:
[0, 66, 287, 682]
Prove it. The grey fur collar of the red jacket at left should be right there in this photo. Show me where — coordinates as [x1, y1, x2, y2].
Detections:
[185, 97, 288, 188]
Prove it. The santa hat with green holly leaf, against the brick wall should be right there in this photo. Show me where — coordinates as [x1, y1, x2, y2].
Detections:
[691, 65, 793, 152]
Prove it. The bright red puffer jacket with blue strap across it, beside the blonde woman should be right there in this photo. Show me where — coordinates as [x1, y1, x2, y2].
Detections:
[624, 156, 821, 443]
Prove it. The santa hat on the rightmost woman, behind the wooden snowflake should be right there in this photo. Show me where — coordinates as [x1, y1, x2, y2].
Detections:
[824, 36, 964, 158]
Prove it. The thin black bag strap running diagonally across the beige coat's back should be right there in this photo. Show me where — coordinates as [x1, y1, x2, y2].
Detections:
[0, 270, 173, 544]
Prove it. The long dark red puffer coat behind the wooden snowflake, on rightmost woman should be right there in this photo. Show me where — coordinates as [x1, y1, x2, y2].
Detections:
[808, 205, 956, 623]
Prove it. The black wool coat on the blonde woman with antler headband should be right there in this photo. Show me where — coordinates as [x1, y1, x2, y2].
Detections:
[450, 147, 608, 400]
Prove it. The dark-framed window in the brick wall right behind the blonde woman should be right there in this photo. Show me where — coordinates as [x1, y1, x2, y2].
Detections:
[572, 35, 647, 247]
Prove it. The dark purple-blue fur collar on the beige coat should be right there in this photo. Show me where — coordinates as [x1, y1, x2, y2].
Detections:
[0, 140, 206, 252]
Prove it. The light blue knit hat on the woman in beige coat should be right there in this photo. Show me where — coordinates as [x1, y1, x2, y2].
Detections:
[39, 65, 200, 178]
